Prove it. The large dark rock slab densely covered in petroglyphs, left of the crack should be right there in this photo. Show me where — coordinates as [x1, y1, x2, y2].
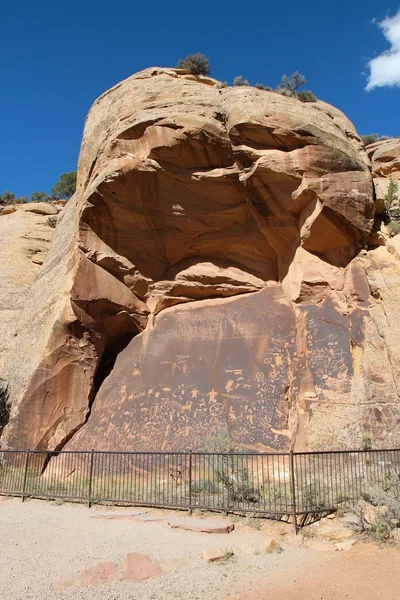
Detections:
[69, 285, 296, 450]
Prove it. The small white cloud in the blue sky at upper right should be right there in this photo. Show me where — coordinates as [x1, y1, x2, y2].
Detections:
[365, 10, 400, 91]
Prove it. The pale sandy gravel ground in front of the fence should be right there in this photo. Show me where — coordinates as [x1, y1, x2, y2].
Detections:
[0, 499, 400, 600]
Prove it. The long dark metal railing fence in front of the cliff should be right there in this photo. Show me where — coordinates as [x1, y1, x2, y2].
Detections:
[0, 449, 400, 525]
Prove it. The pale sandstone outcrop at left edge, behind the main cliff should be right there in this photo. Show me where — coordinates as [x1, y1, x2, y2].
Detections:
[0, 202, 58, 376]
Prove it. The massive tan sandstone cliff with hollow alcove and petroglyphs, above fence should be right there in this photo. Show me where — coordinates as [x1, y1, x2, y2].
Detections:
[4, 69, 400, 450]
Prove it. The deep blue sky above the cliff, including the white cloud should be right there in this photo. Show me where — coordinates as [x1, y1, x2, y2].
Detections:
[0, 0, 400, 195]
